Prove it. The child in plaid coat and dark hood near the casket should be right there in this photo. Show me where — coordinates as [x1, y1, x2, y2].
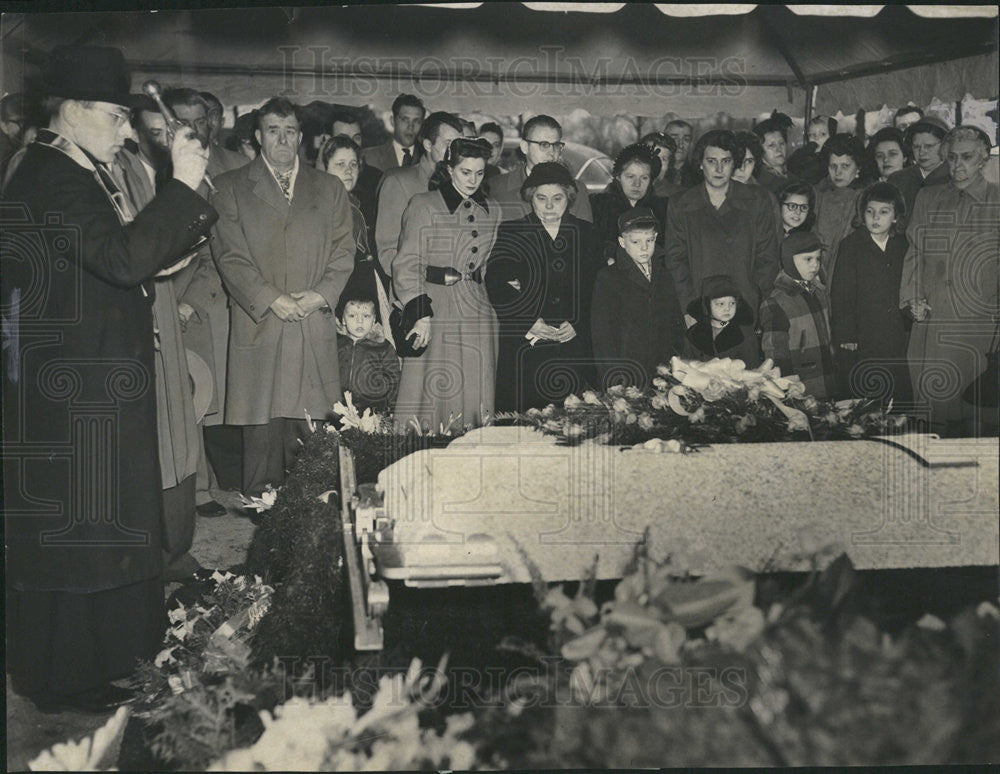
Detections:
[760, 231, 835, 398]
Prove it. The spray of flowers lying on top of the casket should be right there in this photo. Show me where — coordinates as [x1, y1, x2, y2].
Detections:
[505, 357, 906, 452]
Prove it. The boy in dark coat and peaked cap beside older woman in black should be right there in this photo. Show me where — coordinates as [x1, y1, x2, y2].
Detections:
[590, 207, 684, 387]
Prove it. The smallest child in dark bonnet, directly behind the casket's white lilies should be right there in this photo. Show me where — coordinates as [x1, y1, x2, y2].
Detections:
[684, 274, 761, 368]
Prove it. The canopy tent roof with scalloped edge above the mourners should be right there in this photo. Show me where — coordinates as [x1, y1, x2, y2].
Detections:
[3, 3, 998, 121]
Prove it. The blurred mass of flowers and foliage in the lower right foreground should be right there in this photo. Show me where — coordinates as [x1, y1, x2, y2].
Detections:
[470, 552, 1000, 770]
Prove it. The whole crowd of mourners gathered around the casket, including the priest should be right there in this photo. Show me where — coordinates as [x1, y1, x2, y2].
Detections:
[0, 47, 998, 706]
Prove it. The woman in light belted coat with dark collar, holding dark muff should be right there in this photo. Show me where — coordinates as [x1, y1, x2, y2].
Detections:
[392, 137, 500, 431]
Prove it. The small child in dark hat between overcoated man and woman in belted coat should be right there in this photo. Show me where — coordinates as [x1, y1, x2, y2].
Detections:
[336, 272, 400, 412]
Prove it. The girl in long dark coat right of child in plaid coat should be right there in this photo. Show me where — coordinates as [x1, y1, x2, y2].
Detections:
[830, 183, 912, 402]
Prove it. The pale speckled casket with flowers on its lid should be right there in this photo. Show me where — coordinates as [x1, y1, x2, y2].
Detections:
[370, 427, 1000, 586]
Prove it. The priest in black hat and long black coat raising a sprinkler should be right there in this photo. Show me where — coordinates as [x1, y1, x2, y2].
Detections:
[2, 46, 218, 711]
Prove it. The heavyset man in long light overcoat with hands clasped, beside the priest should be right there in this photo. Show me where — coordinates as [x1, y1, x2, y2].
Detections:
[212, 97, 355, 495]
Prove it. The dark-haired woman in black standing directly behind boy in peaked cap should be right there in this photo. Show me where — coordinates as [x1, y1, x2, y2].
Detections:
[590, 143, 667, 263]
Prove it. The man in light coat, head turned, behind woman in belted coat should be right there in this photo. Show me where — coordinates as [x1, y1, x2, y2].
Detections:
[375, 112, 462, 274]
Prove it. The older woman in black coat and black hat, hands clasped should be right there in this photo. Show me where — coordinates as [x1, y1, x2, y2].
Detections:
[485, 162, 599, 412]
